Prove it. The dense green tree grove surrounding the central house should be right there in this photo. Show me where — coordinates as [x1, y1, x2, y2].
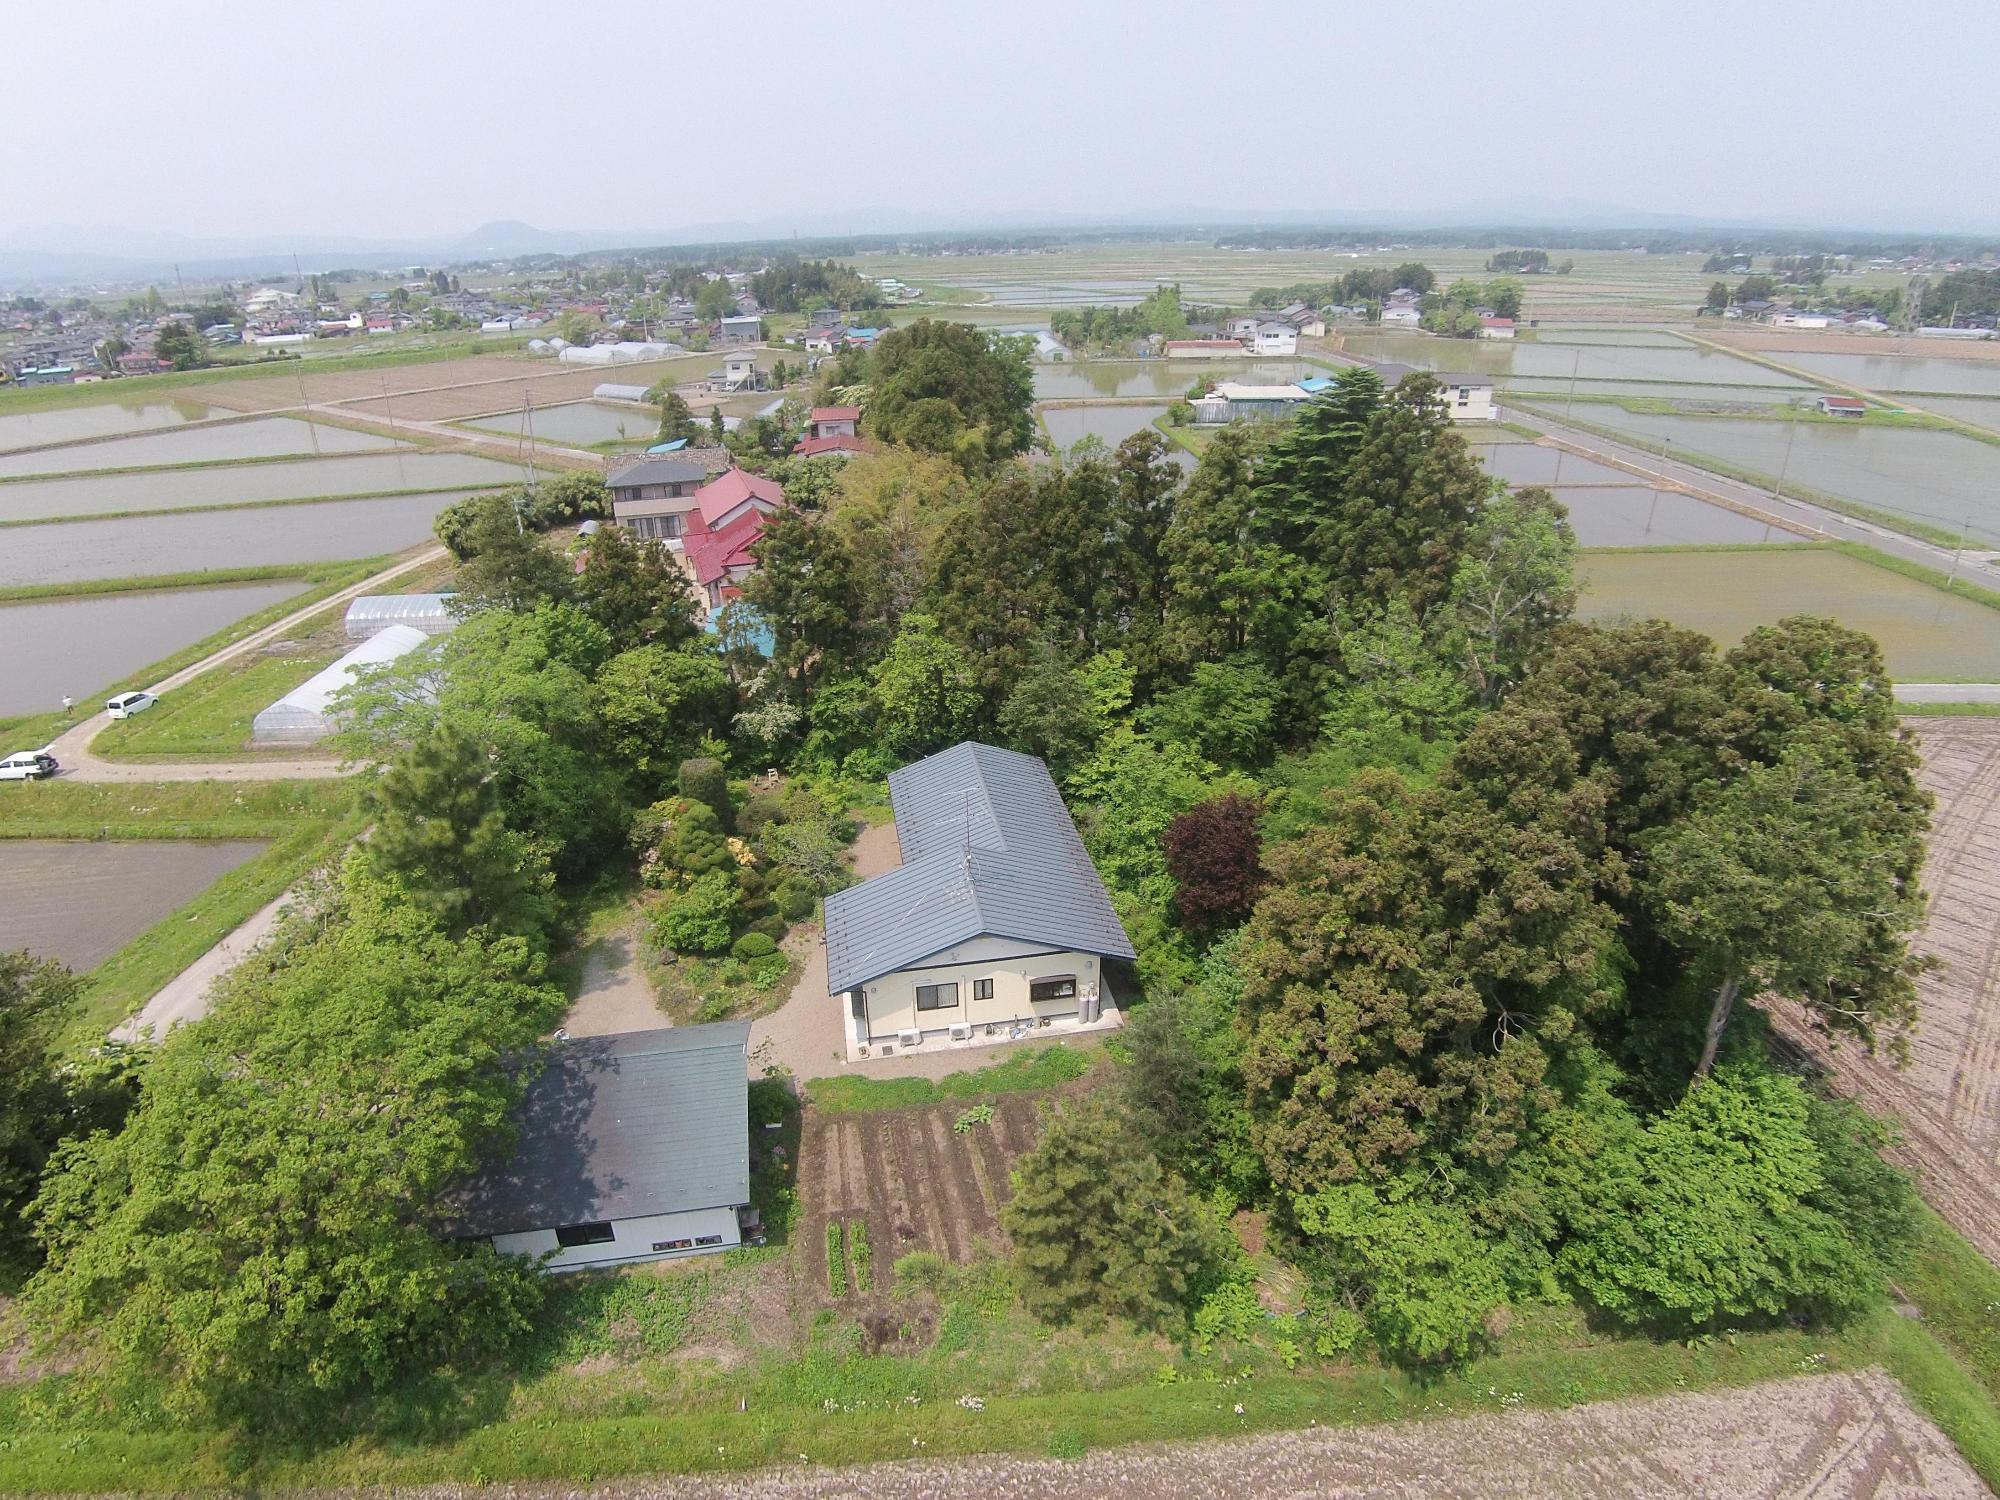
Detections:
[0, 326, 1928, 1426]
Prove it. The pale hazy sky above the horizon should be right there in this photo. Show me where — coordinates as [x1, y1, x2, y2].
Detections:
[0, 0, 2000, 248]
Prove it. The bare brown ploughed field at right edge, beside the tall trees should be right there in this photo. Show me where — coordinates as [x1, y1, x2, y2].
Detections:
[1774, 718, 2000, 1258]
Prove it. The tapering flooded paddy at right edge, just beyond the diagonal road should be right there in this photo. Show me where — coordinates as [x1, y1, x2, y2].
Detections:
[1552, 408, 2000, 538]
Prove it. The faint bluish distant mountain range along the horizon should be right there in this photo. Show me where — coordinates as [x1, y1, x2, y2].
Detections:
[0, 198, 1992, 288]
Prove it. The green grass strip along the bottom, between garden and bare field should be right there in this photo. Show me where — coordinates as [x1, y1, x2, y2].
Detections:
[0, 1250, 2000, 1492]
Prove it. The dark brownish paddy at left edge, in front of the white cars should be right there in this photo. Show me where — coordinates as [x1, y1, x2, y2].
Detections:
[0, 840, 268, 974]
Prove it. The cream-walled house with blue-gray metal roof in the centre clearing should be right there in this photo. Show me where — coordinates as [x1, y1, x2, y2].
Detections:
[826, 740, 1134, 1060]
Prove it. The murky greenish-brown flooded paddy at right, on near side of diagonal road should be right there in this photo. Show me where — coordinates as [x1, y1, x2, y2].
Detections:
[1578, 548, 2000, 682]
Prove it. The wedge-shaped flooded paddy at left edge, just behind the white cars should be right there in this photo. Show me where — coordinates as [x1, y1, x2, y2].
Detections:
[0, 580, 306, 716]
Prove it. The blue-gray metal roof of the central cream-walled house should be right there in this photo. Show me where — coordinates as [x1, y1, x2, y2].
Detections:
[826, 740, 1136, 994]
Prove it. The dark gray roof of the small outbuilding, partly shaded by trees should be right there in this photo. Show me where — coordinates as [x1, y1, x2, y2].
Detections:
[458, 1020, 750, 1234]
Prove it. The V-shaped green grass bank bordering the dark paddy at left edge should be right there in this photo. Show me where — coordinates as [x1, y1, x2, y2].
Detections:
[0, 778, 364, 1046]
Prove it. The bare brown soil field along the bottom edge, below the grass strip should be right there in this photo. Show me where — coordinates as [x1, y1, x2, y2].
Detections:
[312, 1370, 1990, 1500]
